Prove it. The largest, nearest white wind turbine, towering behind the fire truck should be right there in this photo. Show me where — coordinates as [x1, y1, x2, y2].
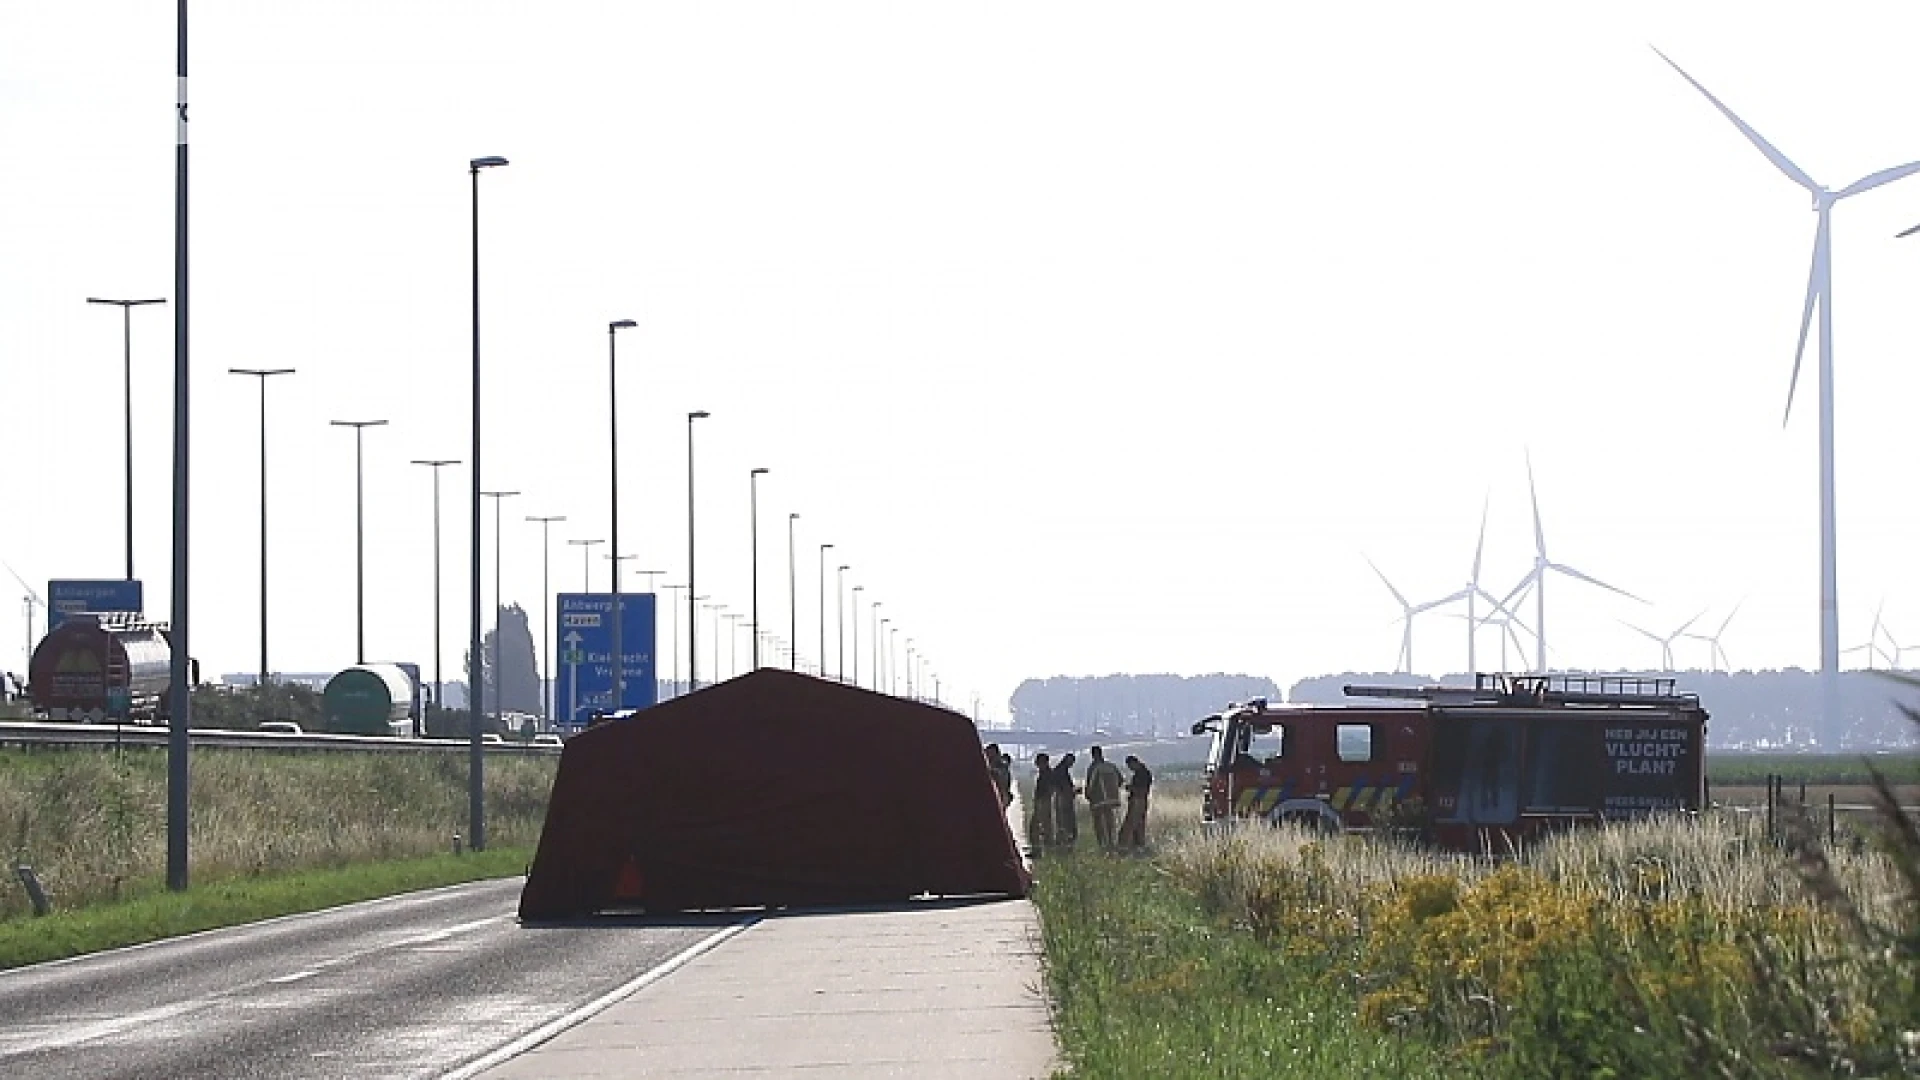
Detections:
[1653, 48, 1920, 726]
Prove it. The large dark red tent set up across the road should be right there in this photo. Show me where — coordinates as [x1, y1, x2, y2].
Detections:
[520, 669, 1033, 919]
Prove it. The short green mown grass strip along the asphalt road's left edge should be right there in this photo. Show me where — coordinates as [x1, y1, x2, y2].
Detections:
[0, 847, 534, 970]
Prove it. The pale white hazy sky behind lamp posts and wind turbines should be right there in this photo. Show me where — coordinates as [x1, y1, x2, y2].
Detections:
[0, 0, 1920, 717]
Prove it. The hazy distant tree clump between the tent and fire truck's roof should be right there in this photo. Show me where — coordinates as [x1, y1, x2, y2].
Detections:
[1008, 675, 1281, 736]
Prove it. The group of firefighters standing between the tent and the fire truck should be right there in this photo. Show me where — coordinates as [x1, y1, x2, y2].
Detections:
[985, 744, 1154, 851]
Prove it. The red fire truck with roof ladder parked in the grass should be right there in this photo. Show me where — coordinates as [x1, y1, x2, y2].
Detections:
[1192, 675, 1707, 851]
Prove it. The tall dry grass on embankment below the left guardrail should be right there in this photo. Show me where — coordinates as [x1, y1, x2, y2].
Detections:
[0, 749, 555, 926]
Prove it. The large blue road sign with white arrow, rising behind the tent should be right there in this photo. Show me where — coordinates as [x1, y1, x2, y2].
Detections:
[553, 592, 655, 730]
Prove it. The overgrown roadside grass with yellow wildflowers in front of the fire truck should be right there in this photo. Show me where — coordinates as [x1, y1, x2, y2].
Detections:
[1035, 774, 1920, 1078]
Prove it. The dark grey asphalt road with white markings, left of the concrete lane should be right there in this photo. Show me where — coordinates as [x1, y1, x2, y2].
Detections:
[0, 878, 728, 1080]
